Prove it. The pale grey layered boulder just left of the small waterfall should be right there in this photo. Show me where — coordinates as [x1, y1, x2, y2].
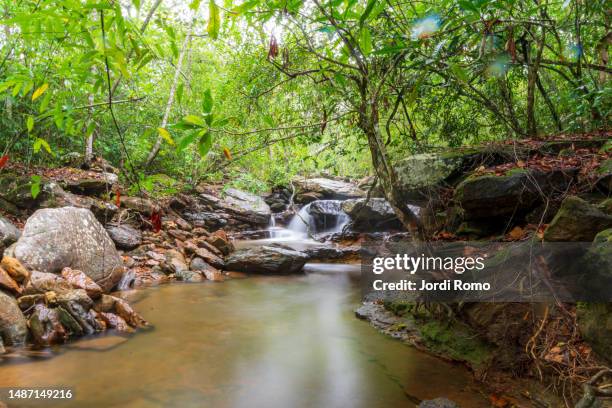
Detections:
[200, 188, 272, 225]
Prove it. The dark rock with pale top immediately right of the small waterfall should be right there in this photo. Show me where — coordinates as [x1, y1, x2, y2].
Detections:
[342, 198, 404, 232]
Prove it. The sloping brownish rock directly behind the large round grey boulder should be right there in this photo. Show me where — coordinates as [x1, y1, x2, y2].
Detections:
[40, 182, 119, 223]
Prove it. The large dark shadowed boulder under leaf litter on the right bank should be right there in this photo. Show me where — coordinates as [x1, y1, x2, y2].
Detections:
[454, 169, 574, 219]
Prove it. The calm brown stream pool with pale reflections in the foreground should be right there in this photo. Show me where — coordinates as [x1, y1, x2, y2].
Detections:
[0, 265, 487, 408]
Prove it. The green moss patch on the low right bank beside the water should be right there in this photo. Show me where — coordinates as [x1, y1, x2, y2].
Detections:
[420, 320, 494, 368]
